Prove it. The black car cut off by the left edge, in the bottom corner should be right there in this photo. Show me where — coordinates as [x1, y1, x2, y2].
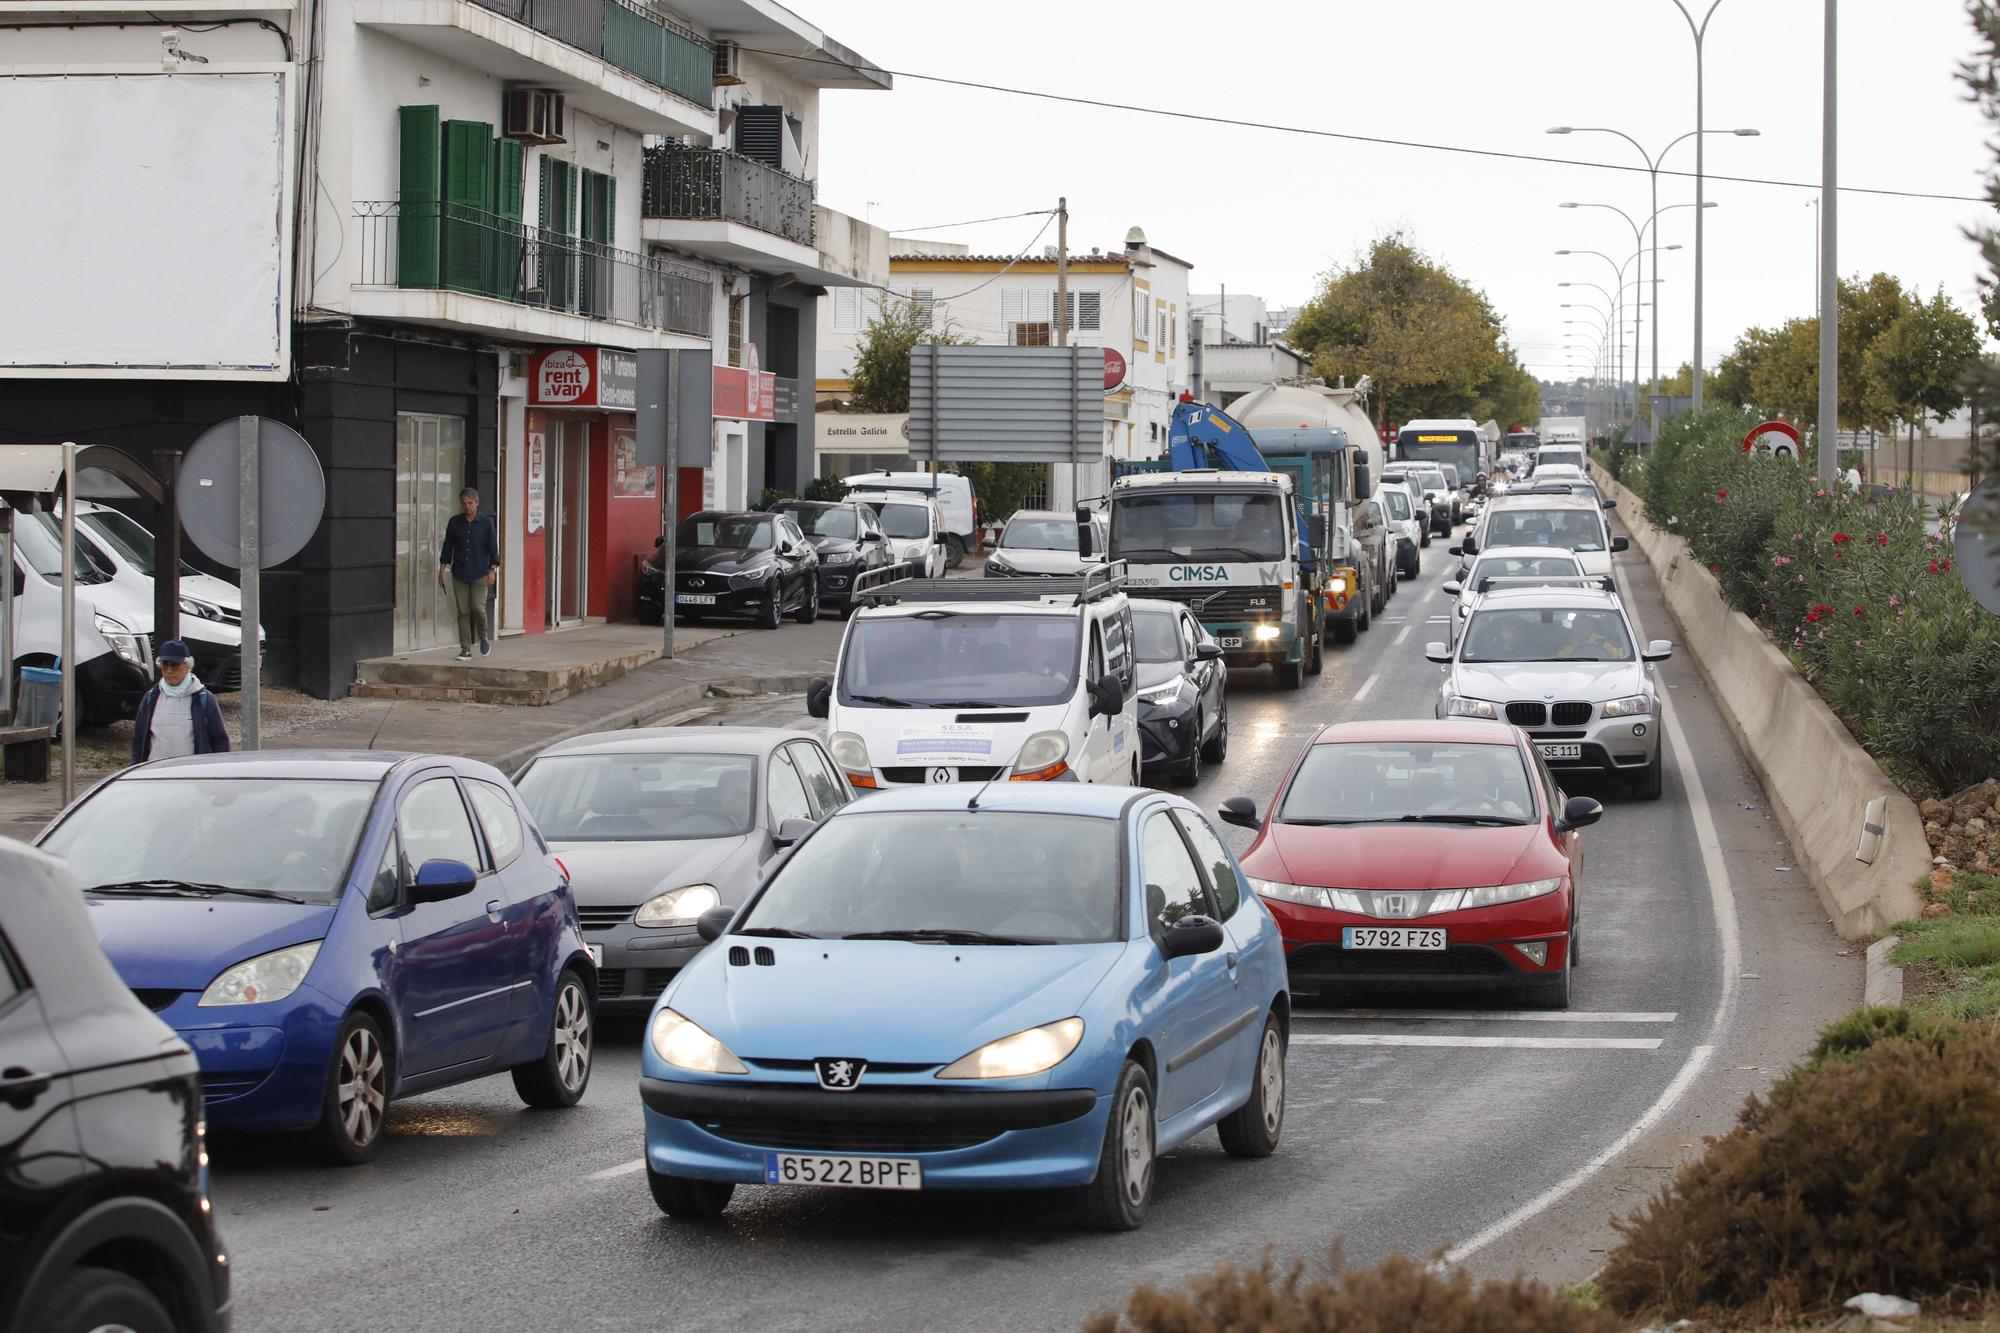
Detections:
[0, 839, 230, 1333]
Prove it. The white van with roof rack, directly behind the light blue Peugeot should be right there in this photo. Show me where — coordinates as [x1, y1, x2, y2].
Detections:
[806, 562, 1140, 791]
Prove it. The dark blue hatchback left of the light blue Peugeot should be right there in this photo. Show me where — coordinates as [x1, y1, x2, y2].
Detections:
[36, 751, 596, 1163]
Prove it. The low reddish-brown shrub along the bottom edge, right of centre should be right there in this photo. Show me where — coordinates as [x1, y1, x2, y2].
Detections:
[1084, 1249, 1624, 1333]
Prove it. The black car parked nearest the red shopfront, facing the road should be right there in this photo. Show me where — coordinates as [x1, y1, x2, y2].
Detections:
[638, 508, 820, 628]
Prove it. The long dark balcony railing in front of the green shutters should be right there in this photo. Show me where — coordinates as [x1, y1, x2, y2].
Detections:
[354, 200, 714, 338]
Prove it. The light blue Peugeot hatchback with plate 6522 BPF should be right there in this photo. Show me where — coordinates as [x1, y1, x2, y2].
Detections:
[640, 783, 1290, 1231]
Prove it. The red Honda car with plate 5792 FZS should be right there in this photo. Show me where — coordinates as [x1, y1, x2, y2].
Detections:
[1220, 719, 1604, 1009]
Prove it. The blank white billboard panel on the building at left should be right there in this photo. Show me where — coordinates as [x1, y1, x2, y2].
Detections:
[0, 68, 292, 378]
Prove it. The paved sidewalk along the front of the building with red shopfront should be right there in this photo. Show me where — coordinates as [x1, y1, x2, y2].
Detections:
[0, 618, 846, 839]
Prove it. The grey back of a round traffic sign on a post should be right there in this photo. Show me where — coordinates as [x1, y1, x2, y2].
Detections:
[178, 416, 326, 568]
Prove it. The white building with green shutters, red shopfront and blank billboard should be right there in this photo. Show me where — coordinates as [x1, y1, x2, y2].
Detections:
[0, 0, 890, 697]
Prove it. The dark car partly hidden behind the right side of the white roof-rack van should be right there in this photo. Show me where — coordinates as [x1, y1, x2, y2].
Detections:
[1132, 596, 1230, 787]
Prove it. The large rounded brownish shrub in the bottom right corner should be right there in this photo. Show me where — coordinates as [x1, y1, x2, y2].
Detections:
[1598, 1013, 2000, 1321]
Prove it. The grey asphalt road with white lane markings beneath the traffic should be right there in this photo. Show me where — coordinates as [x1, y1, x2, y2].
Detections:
[214, 520, 1860, 1333]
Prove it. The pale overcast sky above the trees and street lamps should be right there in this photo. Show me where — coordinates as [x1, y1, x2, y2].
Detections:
[794, 0, 1990, 376]
